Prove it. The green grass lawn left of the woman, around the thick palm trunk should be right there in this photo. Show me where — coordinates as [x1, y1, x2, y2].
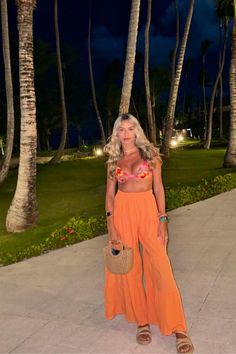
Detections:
[0, 159, 105, 257]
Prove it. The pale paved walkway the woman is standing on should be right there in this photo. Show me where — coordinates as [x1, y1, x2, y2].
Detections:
[0, 189, 236, 354]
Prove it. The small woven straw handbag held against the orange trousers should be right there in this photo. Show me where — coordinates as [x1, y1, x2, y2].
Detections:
[103, 240, 134, 274]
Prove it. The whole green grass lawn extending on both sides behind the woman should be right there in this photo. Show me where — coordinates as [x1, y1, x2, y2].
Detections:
[0, 149, 236, 257]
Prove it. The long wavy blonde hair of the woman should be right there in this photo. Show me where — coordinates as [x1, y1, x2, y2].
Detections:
[103, 113, 162, 178]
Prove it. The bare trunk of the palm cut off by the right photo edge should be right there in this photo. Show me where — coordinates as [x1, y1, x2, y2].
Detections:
[223, 23, 236, 167]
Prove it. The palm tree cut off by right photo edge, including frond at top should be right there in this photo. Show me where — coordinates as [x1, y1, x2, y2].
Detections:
[220, 0, 236, 167]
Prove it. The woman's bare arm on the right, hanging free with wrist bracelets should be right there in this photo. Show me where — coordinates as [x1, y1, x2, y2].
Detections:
[152, 160, 168, 246]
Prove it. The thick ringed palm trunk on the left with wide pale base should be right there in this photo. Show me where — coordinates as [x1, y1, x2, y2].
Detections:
[6, 0, 38, 232]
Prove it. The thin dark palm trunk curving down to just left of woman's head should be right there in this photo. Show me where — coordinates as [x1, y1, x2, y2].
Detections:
[88, 16, 106, 145]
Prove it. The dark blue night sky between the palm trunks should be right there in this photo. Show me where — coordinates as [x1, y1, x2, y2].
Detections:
[1, 0, 230, 144]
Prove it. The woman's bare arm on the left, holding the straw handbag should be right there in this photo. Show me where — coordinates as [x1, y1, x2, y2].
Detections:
[106, 169, 119, 241]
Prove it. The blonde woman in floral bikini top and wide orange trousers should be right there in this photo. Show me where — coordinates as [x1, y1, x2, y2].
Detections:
[104, 114, 193, 354]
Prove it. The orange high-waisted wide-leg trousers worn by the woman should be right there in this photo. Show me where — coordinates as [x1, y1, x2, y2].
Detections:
[104, 190, 186, 335]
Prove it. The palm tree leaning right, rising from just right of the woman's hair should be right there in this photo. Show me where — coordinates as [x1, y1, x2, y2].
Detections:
[162, 0, 195, 157]
